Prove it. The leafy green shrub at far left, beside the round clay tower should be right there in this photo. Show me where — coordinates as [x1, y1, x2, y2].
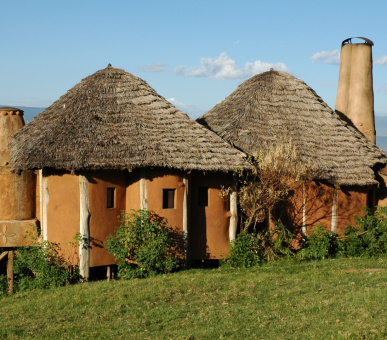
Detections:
[14, 233, 80, 290]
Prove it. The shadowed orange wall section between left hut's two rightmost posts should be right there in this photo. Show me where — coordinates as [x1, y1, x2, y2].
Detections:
[188, 173, 231, 260]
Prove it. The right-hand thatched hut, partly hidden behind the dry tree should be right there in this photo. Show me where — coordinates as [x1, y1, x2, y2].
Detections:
[198, 69, 387, 234]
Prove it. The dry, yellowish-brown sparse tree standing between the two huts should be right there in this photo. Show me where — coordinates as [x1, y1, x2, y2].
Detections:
[228, 139, 317, 231]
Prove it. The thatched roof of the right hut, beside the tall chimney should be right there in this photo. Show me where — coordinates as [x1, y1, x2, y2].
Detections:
[198, 70, 387, 185]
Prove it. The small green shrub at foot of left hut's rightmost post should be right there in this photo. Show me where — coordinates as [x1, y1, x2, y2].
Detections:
[222, 231, 263, 268]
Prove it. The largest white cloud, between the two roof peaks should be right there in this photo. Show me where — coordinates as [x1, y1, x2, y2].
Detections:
[174, 52, 288, 80]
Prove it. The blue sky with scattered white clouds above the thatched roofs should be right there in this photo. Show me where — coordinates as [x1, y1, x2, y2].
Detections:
[0, 0, 387, 118]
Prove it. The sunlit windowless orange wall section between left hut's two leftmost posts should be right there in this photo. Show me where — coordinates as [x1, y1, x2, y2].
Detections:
[45, 173, 80, 265]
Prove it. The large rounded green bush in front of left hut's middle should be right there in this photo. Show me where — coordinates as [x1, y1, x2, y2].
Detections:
[106, 210, 178, 279]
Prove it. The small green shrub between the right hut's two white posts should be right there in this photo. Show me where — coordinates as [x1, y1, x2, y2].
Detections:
[297, 226, 338, 260]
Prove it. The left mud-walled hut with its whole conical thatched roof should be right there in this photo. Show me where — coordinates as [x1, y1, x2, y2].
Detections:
[10, 65, 249, 277]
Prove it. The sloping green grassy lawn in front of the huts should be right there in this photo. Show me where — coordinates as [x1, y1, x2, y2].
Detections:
[0, 257, 387, 339]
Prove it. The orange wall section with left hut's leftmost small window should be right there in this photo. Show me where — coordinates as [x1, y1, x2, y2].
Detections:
[87, 171, 127, 267]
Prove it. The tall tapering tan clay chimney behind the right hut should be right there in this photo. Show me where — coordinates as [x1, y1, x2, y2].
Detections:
[335, 38, 376, 143]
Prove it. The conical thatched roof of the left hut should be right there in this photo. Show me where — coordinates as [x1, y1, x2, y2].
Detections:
[10, 65, 249, 172]
